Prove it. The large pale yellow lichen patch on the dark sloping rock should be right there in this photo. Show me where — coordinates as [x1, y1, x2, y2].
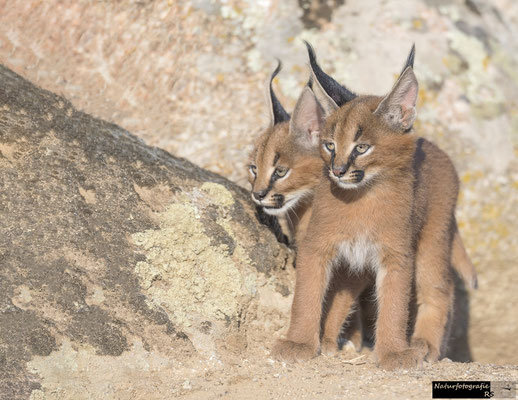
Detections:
[132, 188, 255, 338]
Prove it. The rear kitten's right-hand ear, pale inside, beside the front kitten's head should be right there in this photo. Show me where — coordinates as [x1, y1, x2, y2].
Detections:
[290, 86, 324, 149]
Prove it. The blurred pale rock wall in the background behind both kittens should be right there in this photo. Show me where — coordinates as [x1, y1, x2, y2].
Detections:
[0, 0, 518, 364]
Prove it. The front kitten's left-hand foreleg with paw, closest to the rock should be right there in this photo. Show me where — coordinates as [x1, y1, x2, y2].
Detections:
[272, 246, 333, 361]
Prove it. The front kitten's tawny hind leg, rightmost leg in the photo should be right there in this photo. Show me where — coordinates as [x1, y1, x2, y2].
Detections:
[412, 224, 454, 361]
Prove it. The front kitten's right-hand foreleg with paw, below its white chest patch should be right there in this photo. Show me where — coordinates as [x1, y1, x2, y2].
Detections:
[375, 249, 424, 370]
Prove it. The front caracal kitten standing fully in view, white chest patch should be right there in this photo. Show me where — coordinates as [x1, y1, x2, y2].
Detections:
[270, 43, 478, 369]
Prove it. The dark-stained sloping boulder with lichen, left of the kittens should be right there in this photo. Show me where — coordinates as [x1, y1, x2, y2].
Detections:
[0, 67, 290, 399]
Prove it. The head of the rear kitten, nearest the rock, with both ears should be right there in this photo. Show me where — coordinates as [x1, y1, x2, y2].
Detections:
[248, 63, 324, 215]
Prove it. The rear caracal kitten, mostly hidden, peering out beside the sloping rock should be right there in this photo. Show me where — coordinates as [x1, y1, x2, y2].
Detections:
[248, 63, 368, 353]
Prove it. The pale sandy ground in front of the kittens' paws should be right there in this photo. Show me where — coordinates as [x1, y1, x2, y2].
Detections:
[178, 346, 518, 400]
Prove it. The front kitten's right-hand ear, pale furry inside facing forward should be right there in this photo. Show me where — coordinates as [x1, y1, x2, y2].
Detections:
[374, 67, 419, 132]
